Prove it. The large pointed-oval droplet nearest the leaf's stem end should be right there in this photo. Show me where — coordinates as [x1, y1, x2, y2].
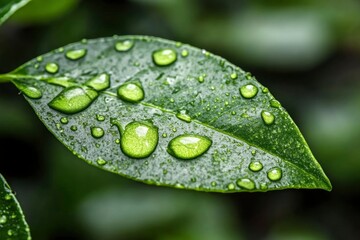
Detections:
[48, 86, 98, 114]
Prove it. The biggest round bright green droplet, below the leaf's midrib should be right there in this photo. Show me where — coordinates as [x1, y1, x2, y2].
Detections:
[120, 122, 159, 158]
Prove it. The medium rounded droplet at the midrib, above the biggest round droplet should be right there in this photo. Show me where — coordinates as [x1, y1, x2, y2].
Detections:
[117, 82, 144, 103]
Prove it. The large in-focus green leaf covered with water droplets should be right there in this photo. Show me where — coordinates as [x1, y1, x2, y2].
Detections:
[0, 36, 331, 192]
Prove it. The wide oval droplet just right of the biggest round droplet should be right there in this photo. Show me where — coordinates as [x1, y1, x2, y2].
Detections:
[167, 134, 212, 159]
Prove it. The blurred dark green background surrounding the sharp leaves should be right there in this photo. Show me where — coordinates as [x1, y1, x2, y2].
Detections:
[0, 0, 360, 240]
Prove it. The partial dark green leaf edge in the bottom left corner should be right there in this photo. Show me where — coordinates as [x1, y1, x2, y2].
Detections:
[0, 174, 31, 240]
